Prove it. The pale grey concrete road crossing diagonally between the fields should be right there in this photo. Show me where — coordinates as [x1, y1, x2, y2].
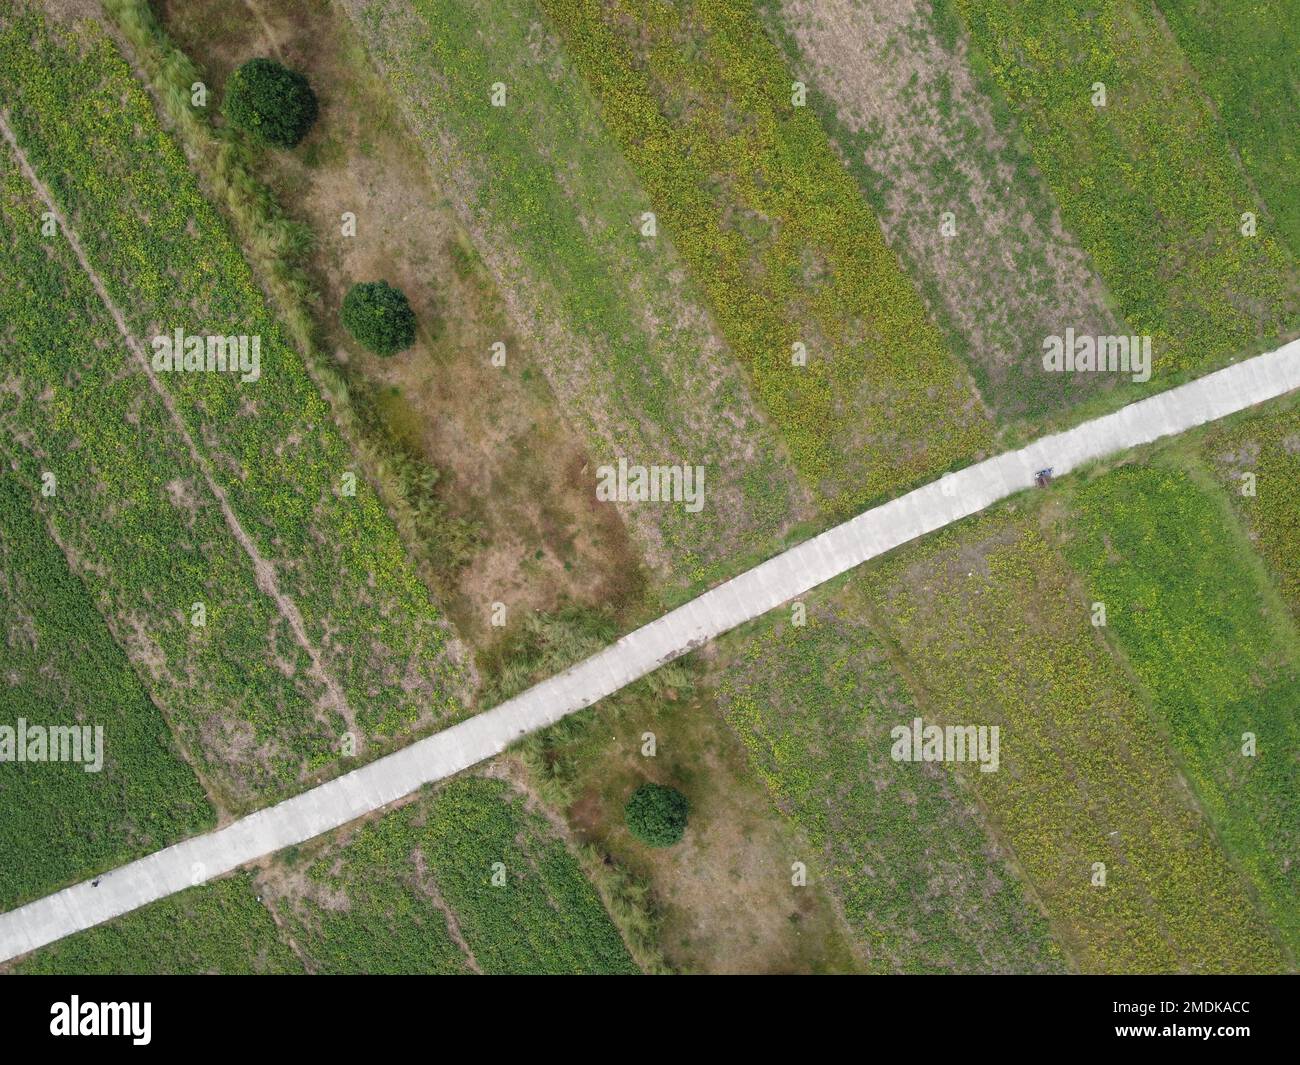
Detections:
[0, 341, 1300, 961]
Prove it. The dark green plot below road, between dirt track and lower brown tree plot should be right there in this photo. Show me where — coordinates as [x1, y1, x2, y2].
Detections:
[278, 778, 636, 973]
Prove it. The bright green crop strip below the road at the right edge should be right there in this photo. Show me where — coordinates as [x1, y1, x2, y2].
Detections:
[1066, 467, 1300, 954]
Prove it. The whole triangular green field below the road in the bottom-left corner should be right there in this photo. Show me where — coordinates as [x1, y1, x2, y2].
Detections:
[20, 778, 637, 974]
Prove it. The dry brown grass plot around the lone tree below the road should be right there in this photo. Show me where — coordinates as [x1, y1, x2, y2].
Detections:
[521, 658, 863, 974]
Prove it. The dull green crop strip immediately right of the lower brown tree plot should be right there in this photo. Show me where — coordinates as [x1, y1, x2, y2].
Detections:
[714, 600, 1063, 973]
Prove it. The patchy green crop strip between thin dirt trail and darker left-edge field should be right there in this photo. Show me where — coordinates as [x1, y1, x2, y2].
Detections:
[0, 137, 332, 805]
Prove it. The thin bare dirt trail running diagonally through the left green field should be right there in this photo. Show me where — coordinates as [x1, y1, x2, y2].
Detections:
[0, 113, 354, 724]
